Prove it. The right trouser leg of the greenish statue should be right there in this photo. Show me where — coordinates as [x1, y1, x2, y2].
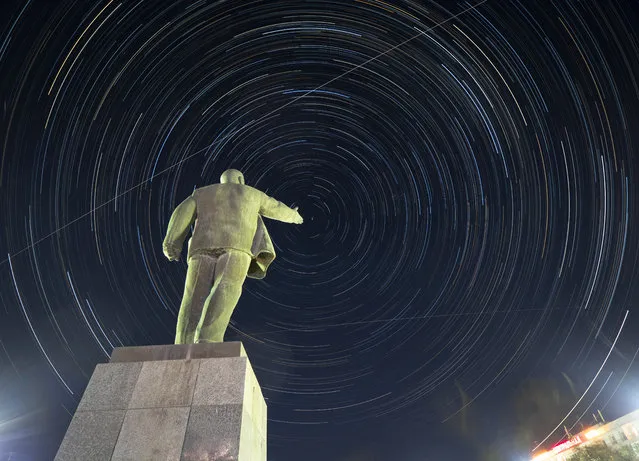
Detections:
[195, 250, 251, 343]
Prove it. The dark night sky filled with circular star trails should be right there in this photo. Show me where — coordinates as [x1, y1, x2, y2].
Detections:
[0, 0, 639, 461]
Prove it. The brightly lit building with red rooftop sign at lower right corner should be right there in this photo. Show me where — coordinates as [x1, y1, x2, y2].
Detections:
[532, 410, 639, 461]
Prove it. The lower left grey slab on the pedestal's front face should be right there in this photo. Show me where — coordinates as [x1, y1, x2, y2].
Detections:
[55, 410, 125, 461]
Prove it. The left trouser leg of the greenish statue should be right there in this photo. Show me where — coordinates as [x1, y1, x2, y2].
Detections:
[175, 255, 216, 344]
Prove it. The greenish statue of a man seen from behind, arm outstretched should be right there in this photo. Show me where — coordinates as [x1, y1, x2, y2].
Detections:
[162, 170, 303, 344]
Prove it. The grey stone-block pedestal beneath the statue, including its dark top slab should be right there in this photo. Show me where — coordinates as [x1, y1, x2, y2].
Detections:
[55, 342, 266, 461]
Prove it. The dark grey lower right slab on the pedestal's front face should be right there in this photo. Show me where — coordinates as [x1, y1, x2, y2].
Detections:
[181, 405, 243, 461]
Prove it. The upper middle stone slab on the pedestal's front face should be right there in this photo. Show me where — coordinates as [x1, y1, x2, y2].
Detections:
[129, 360, 200, 408]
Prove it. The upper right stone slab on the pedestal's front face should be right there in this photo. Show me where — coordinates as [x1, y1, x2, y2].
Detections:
[193, 357, 248, 405]
